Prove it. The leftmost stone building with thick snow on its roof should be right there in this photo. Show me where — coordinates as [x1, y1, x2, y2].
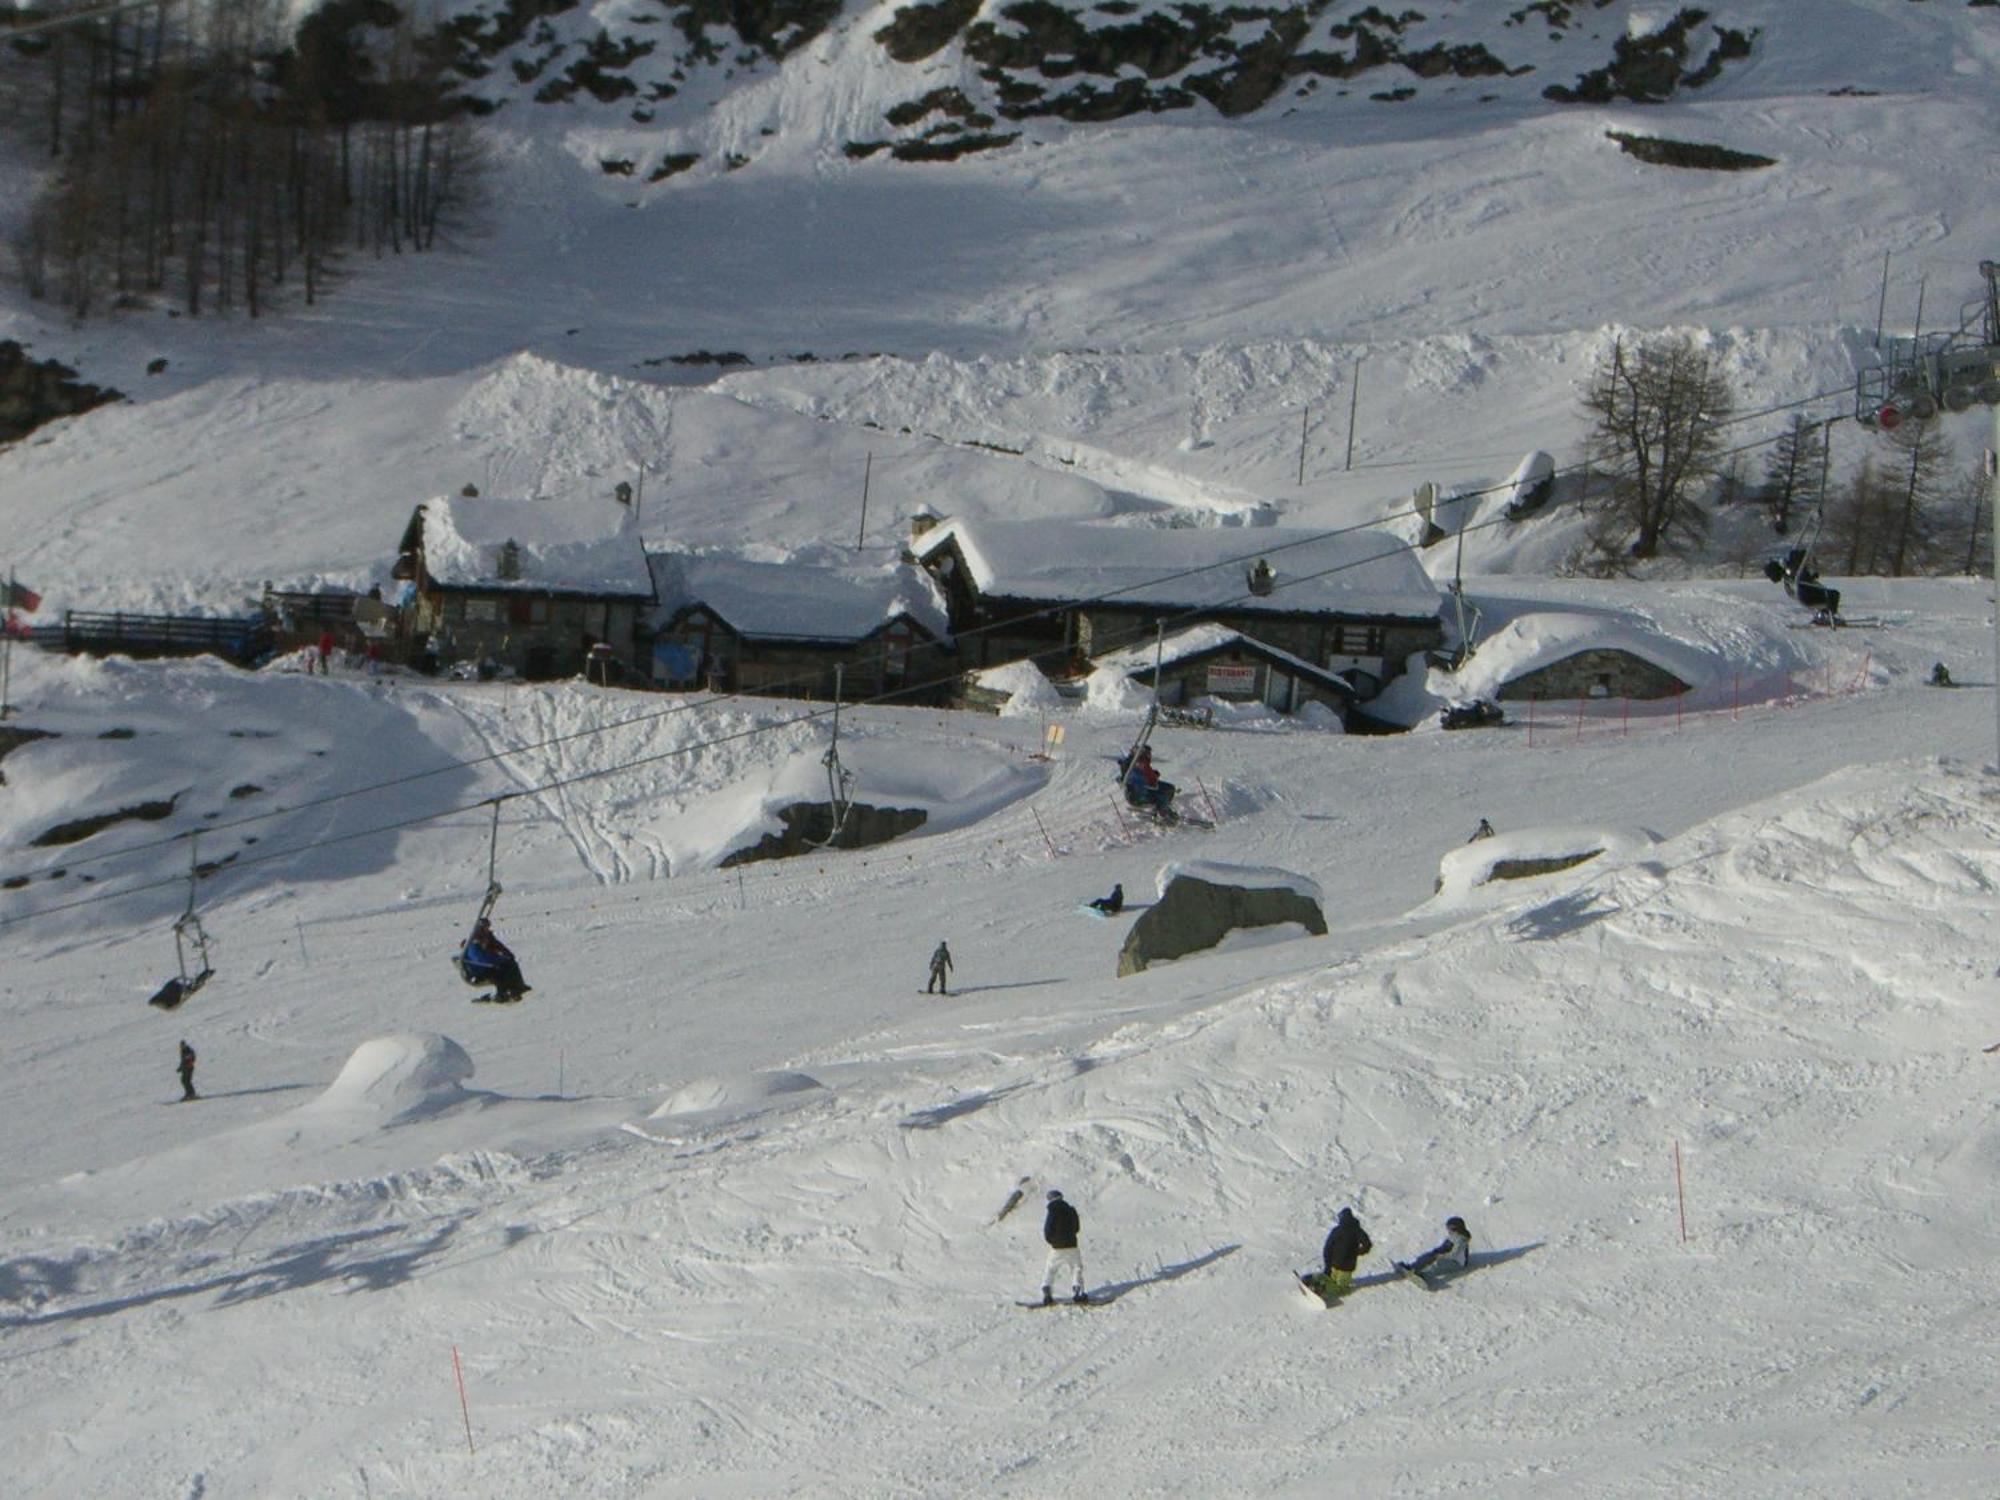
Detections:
[396, 494, 654, 678]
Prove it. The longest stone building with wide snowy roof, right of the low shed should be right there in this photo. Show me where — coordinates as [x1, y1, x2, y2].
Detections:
[910, 518, 1442, 686]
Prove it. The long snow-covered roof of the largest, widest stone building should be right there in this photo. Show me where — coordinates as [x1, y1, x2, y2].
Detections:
[914, 518, 1440, 620]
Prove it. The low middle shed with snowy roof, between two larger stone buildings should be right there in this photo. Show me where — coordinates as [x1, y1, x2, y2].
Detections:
[648, 552, 956, 702]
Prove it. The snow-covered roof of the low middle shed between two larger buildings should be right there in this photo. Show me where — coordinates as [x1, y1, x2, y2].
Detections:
[652, 552, 950, 640]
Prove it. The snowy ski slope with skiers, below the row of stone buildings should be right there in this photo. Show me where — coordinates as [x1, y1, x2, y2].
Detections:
[0, 580, 2000, 1496]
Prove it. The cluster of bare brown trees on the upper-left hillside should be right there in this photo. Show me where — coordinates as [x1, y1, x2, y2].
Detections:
[0, 0, 478, 318]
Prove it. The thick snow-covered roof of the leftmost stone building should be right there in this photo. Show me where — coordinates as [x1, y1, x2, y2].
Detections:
[422, 496, 652, 600]
